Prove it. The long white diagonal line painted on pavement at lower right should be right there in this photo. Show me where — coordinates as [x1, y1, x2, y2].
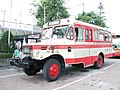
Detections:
[53, 63, 118, 90]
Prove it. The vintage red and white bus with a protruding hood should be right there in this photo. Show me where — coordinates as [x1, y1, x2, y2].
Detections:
[11, 19, 113, 81]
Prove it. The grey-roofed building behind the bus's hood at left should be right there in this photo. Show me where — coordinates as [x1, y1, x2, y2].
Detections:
[0, 26, 42, 45]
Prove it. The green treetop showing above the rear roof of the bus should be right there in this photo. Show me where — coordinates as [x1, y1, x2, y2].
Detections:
[76, 12, 107, 27]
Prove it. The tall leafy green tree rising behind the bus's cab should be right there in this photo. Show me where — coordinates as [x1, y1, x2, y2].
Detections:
[36, 0, 69, 26]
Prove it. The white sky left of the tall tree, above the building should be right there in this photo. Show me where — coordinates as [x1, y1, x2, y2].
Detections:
[0, 0, 33, 29]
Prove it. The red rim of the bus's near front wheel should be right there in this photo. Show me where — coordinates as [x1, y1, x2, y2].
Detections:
[49, 64, 59, 78]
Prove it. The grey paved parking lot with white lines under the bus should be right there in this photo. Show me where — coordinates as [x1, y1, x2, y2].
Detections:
[0, 59, 120, 90]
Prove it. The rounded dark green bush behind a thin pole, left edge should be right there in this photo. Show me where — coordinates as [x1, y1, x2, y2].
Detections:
[0, 31, 15, 53]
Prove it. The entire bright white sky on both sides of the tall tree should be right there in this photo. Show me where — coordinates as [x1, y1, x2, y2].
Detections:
[0, 0, 120, 34]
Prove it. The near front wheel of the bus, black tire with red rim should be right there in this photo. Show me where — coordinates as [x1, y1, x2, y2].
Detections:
[43, 59, 61, 82]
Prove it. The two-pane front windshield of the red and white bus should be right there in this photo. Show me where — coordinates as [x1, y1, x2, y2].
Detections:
[42, 26, 69, 39]
